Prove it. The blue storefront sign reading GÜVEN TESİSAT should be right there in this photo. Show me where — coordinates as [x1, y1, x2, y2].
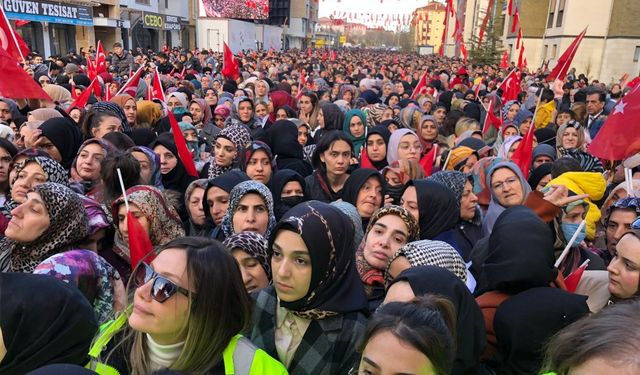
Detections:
[0, 0, 93, 26]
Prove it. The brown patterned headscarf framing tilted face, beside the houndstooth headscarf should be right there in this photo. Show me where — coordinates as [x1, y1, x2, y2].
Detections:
[356, 206, 420, 285]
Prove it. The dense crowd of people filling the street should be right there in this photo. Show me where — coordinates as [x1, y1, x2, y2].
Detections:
[0, 43, 640, 375]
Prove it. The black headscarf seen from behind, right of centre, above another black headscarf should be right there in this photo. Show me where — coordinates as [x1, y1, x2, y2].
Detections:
[483, 206, 557, 294]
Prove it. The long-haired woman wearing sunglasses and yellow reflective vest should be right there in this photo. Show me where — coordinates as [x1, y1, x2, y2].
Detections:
[89, 237, 287, 375]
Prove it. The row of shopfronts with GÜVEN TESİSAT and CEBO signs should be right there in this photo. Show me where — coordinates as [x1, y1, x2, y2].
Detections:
[8, 0, 198, 57]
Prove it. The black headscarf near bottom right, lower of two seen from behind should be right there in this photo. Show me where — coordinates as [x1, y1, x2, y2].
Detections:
[493, 287, 589, 375]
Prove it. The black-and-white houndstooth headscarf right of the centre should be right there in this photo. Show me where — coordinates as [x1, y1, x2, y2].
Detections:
[384, 240, 467, 283]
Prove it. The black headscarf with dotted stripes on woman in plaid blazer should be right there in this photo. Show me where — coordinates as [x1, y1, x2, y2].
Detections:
[269, 201, 367, 316]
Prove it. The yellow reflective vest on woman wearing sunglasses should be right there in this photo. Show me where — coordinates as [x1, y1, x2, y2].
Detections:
[85, 314, 288, 375]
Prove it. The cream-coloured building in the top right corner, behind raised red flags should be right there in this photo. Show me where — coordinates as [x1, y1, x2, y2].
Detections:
[504, 0, 640, 83]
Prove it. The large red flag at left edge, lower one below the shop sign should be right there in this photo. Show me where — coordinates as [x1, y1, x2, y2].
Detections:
[0, 48, 51, 100]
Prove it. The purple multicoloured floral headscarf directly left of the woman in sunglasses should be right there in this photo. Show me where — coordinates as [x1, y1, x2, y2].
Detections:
[33, 250, 127, 325]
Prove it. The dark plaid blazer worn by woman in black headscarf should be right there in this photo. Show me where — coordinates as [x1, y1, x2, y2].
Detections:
[251, 286, 367, 375]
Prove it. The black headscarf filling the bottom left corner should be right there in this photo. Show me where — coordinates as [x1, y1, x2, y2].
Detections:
[0, 273, 98, 375]
